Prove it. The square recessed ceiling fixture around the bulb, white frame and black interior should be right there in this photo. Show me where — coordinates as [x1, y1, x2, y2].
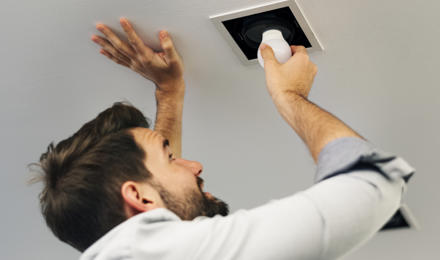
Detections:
[209, 0, 324, 65]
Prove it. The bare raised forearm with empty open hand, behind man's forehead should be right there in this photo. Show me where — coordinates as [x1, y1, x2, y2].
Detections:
[92, 18, 185, 157]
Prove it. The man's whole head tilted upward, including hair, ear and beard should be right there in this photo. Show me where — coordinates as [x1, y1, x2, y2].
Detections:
[34, 103, 228, 251]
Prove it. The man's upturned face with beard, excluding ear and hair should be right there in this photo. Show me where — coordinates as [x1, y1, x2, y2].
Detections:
[132, 127, 229, 220]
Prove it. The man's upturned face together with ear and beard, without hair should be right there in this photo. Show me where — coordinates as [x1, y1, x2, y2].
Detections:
[121, 127, 228, 220]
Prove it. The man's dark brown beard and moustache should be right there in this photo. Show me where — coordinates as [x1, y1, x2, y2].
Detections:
[154, 177, 229, 220]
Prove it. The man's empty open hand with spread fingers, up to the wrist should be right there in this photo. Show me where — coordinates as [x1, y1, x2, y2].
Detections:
[92, 18, 183, 92]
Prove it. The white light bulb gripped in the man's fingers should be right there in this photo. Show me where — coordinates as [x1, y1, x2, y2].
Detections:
[257, 29, 292, 68]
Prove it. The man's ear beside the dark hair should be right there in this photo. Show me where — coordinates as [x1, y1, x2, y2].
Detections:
[121, 181, 158, 217]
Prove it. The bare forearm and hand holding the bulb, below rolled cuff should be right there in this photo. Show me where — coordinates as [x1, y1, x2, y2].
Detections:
[261, 46, 362, 162]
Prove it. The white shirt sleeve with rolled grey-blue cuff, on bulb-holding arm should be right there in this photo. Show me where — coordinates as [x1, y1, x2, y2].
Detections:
[177, 138, 414, 260]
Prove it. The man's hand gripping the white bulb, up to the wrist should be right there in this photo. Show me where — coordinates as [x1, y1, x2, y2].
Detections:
[261, 45, 318, 102]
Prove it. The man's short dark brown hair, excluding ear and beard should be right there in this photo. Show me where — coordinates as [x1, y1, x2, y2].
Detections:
[34, 102, 152, 251]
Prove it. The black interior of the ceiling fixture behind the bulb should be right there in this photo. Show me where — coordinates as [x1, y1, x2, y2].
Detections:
[222, 7, 312, 60]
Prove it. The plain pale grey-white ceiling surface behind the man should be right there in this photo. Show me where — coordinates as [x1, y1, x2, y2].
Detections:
[0, 0, 440, 260]
